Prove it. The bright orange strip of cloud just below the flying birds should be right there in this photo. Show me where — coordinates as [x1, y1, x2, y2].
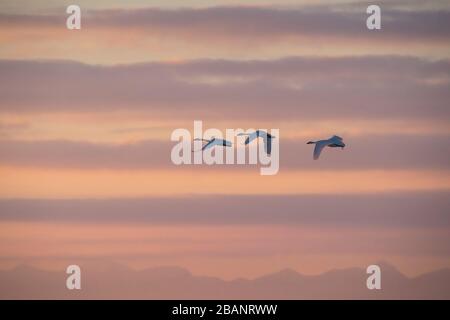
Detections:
[0, 166, 450, 198]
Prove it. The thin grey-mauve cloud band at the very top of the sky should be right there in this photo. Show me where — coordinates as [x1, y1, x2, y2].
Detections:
[0, 3, 450, 42]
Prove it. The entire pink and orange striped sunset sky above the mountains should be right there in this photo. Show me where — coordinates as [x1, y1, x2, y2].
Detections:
[0, 0, 450, 279]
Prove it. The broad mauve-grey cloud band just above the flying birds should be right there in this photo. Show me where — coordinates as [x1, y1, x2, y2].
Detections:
[0, 56, 450, 120]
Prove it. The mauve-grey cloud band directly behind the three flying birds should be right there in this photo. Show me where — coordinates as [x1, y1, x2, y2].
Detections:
[0, 135, 450, 171]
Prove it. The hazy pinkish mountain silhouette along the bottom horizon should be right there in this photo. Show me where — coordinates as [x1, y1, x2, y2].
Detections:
[0, 263, 450, 299]
